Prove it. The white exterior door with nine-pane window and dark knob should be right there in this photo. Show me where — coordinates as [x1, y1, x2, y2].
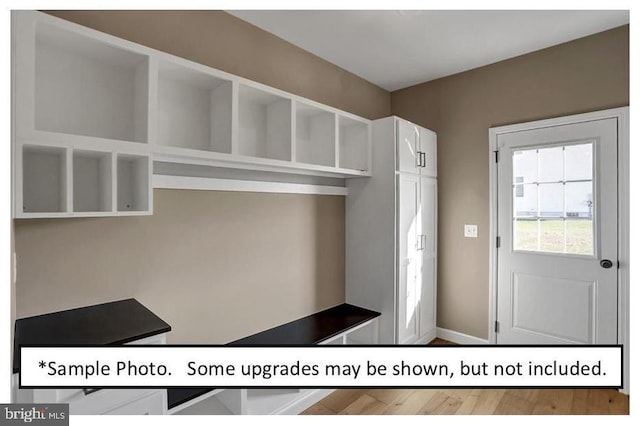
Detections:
[497, 119, 617, 344]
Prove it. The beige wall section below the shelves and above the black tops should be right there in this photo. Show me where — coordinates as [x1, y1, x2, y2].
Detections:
[15, 190, 344, 343]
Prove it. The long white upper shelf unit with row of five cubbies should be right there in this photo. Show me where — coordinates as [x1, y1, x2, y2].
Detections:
[13, 11, 371, 180]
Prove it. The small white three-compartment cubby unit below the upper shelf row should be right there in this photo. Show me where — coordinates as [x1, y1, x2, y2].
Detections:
[16, 143, 150, 218]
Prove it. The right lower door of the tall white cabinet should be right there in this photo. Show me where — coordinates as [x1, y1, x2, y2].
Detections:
[419, 177, 438, 339]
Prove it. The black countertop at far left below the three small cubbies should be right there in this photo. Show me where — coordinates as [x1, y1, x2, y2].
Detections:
[13, 299, 171, 373]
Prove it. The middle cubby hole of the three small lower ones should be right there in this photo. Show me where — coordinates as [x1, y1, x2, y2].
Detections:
[73, 151, 113, 212]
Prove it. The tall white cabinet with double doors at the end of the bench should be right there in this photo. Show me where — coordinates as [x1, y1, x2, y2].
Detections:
[346, 117, 437, 344]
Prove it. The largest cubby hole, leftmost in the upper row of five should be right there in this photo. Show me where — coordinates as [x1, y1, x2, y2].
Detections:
[34, 23, 148, 142]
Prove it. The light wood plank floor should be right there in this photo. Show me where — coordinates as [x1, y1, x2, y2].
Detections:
[302, 339, 629, 415]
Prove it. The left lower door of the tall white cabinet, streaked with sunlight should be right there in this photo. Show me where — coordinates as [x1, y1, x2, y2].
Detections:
[397, 173, 420, 343]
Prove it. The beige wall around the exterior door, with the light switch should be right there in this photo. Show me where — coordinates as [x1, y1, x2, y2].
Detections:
[391, 26, 629, 338]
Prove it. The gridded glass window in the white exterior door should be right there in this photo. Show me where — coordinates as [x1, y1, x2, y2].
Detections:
[512, 142, 595, 256]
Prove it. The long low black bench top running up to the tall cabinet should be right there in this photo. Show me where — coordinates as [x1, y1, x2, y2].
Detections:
[167, 303, 380, 409]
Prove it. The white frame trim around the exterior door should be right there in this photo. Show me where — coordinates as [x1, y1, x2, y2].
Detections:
[488, 106, 630, 394]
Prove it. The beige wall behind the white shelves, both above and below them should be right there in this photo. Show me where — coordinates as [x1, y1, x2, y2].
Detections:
[15, 11, 390, 343]
